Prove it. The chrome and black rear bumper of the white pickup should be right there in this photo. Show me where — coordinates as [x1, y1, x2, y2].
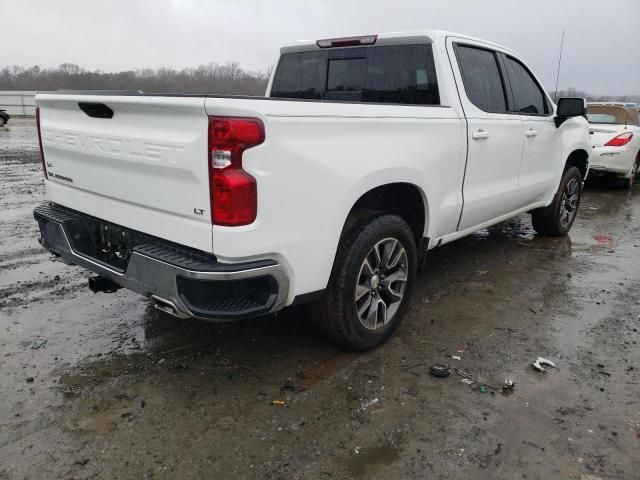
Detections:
[34, 204, 289, 320]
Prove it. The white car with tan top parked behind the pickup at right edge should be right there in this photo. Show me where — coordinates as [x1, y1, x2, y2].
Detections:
[587, 102, 640, 187]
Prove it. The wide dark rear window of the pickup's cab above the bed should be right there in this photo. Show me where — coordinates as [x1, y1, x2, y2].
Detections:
[271, 45, 440, 105]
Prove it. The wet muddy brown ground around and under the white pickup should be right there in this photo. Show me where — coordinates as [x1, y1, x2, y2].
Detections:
[0, 119, 640, 480]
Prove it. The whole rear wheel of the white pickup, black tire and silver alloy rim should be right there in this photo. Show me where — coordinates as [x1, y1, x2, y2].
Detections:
[310, 210, 417, 351]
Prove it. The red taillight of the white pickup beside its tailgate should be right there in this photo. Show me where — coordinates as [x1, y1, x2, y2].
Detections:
[209, 117, 264, 227]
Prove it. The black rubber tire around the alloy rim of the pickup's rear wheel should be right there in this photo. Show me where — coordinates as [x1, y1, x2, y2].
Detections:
[309, 210, 417, 351]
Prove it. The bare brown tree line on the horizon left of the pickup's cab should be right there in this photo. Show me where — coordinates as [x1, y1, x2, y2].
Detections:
[0, 62, 270, 95]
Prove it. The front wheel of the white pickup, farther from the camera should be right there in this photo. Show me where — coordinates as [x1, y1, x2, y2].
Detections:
[531, 167, 582, 237]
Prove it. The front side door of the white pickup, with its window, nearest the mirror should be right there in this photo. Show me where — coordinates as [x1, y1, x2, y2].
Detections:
[501, 54, 564, 204]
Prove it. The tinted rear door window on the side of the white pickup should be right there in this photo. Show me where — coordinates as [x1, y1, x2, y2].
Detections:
[456, 45, 507, 113]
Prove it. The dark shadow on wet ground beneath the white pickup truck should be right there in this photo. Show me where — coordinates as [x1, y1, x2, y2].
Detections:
[144, 219, 544, 348]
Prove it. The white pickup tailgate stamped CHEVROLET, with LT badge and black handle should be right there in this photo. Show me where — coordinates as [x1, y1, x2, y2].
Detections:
[36, 93, 212, 252]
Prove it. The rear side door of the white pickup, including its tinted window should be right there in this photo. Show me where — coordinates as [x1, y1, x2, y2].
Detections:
[448, 38, 523, 230]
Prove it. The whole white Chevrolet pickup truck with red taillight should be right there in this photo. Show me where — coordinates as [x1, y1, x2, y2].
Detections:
[34, 31, 591, 350]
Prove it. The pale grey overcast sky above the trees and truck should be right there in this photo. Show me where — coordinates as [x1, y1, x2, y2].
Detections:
[0, 0, 640, 95]
